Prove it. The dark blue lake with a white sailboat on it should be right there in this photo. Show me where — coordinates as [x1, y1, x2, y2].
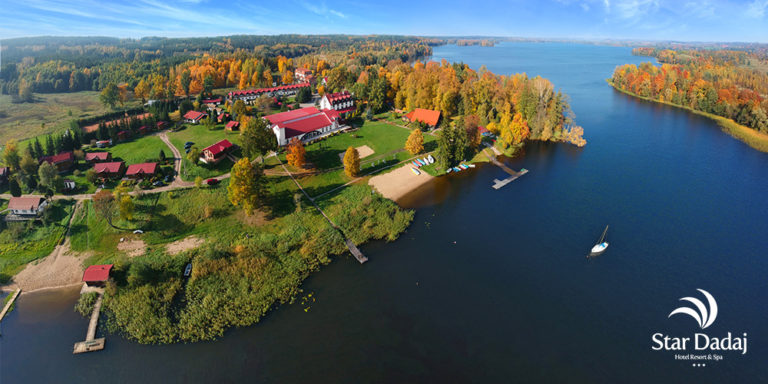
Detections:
[0, 43, 768, 384]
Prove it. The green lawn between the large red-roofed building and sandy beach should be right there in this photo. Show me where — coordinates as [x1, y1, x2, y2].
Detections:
[298, 121, 437, 169]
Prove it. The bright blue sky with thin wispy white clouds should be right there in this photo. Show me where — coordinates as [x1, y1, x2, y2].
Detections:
[0, 0, 768, 43]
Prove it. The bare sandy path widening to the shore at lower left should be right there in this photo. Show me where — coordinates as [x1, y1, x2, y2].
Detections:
[2, 201, 83, 293]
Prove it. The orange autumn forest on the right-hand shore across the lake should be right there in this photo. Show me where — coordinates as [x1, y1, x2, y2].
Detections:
[611, 48, 768, 133]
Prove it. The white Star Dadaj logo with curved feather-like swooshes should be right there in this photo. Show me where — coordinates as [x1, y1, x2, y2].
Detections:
[651, 289, 748, 367]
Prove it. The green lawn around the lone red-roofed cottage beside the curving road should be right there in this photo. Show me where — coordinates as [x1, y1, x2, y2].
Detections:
[168, 124, 240, 181]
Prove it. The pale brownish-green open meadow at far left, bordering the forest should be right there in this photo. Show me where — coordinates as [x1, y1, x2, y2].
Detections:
[0, 91, 140, 143]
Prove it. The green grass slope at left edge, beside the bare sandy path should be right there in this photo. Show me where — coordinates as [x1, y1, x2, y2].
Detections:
[0, 200, 74, 283]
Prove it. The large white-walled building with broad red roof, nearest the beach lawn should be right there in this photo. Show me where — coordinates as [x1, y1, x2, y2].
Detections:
[264, 107, 341, 146]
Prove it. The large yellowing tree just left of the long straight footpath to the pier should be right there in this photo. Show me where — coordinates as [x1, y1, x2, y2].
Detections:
[227, 157, 264, 215]
